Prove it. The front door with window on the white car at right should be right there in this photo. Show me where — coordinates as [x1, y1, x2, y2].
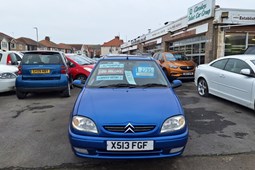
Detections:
[219, 59, 254, 106]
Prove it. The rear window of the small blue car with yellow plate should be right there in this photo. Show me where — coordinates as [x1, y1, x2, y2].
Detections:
[21, 53, 63, 65]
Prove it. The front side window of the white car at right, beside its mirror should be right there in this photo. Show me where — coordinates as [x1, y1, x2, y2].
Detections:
[225, 59, 252, 74]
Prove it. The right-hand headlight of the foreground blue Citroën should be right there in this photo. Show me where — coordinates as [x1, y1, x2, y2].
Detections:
[160, 116, 185, 133]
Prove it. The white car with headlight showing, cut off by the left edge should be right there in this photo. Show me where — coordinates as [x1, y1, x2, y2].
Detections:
[0, 64, 18, 93]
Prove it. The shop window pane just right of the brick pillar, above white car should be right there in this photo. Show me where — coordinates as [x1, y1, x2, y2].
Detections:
[225, 33, 246, 56]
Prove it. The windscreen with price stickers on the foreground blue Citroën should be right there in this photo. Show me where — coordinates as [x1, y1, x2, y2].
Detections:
[86, 60, 168, 88]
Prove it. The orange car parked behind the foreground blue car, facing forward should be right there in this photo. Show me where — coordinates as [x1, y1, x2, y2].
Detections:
[153, 52, 196, 80]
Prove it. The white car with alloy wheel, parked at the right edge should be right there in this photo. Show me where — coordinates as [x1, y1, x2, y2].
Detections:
[195, 55, 255, 109]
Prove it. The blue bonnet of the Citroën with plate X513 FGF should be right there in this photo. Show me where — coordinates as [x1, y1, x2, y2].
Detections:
[74, 88, 183, 125]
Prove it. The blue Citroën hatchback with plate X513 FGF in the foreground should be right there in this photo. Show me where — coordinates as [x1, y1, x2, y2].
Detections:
[69, 56, 188, 159]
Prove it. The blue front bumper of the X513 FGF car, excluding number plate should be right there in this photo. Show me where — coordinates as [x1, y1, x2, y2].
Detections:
[69, 128, 188, 159]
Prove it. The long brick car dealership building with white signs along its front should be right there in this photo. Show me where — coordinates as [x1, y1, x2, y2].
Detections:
[121, 0, 255, 64]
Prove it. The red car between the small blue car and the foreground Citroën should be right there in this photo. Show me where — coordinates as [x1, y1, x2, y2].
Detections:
[66, 55, 94, 81]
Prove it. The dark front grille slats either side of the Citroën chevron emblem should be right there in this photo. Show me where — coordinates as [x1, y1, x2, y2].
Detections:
[104, 125, 155, 133]
